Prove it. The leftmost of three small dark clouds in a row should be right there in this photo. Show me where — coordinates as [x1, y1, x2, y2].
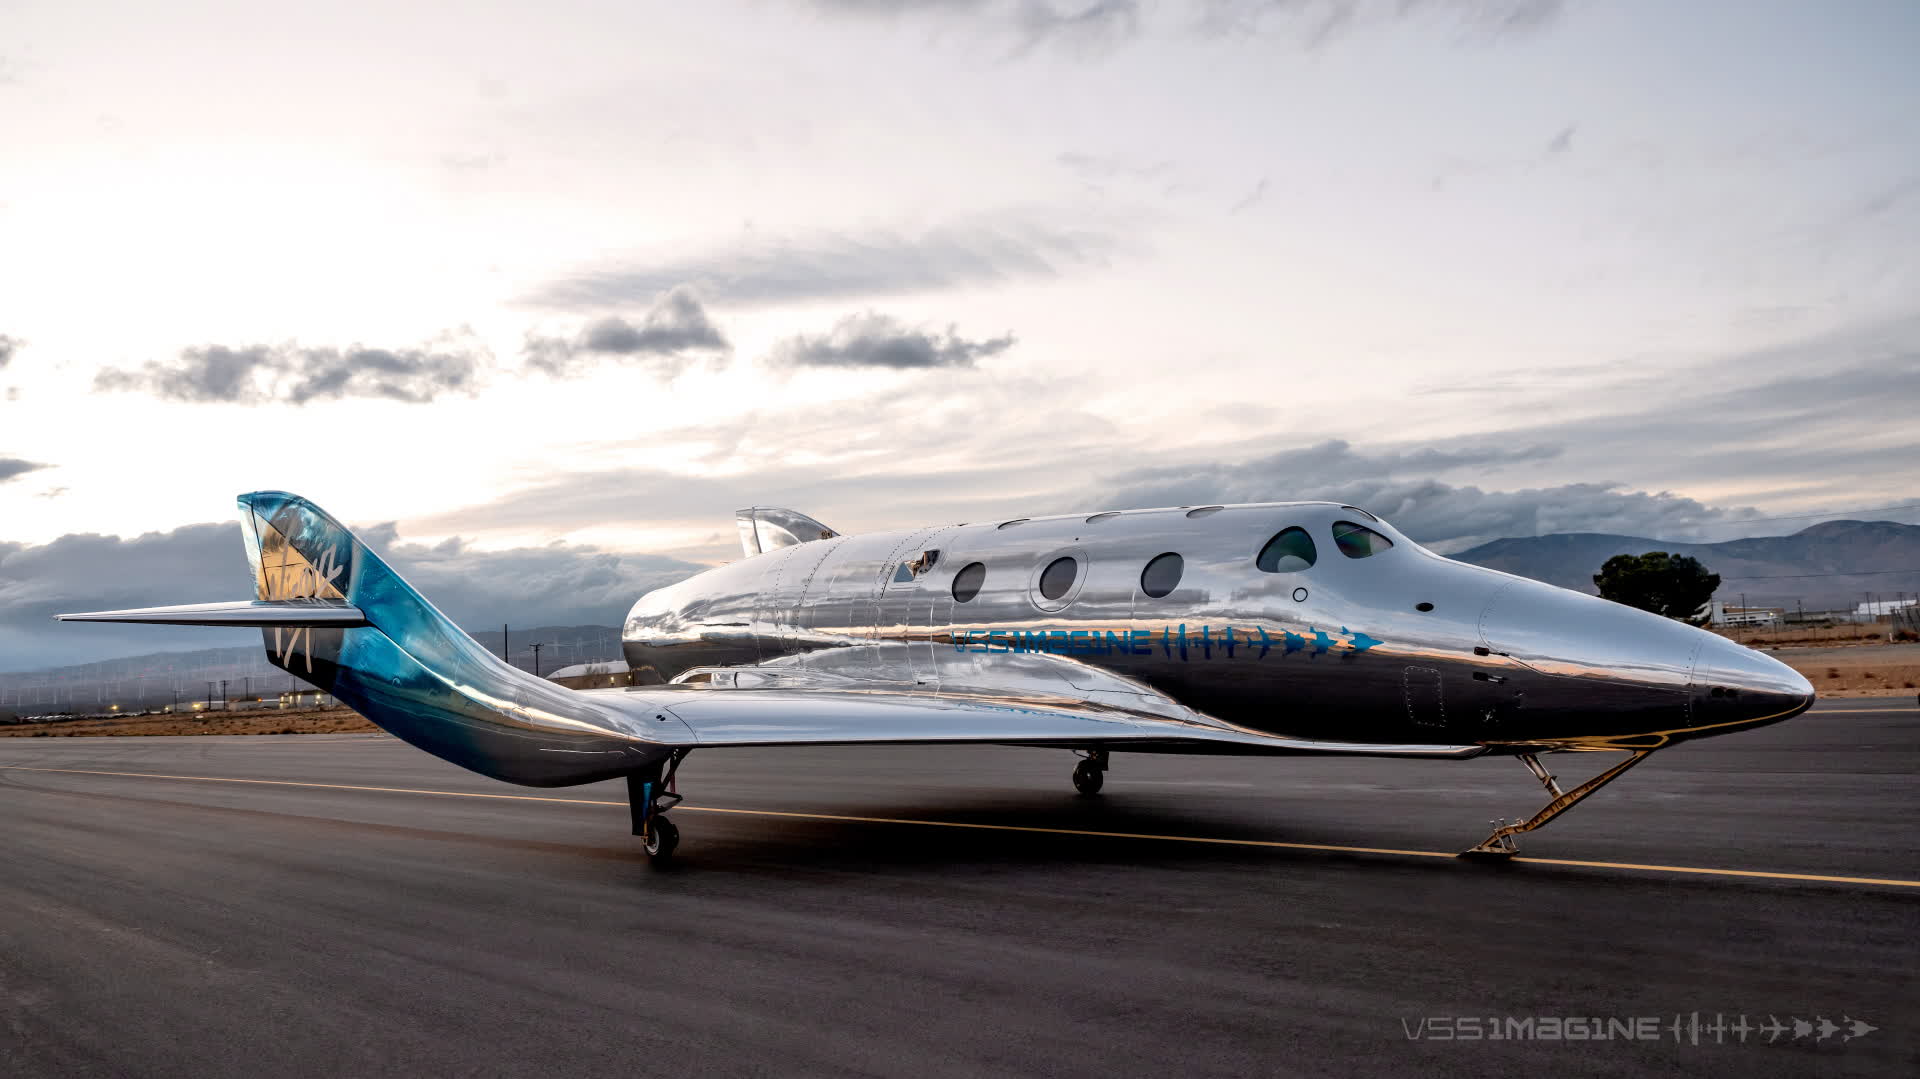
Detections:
[94, 334, 490, 405]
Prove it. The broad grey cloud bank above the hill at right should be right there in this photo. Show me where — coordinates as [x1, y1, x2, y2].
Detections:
[1114, 319, 1920, 551]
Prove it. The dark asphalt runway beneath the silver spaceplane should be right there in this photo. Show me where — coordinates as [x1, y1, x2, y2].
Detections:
[0, 699, 1920, 1077]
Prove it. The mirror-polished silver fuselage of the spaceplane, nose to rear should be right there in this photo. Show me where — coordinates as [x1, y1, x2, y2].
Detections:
[622, 503, 1812, 749]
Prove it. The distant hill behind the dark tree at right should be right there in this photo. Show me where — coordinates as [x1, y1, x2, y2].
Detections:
[1453, 520, 1920, 611]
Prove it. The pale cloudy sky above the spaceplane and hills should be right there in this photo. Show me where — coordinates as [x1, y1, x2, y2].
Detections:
[0, 0, 1920, 670]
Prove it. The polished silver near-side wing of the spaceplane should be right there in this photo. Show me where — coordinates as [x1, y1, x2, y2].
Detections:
[582, 685, 1486, 758]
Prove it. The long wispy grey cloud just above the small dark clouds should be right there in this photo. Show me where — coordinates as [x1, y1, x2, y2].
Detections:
[526, 215, 1121, 311]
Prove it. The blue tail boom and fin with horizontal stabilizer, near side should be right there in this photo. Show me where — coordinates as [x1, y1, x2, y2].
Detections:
[61, 492, 666, 787]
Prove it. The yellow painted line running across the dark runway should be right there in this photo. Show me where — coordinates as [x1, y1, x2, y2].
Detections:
[0, 764, 1920, 889]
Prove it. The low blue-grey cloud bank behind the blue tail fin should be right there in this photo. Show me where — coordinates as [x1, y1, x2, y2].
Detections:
[0, 524, 705, 670]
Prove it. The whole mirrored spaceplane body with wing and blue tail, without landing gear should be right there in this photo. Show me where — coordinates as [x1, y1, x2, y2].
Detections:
[52, 492, 1812, 785]
